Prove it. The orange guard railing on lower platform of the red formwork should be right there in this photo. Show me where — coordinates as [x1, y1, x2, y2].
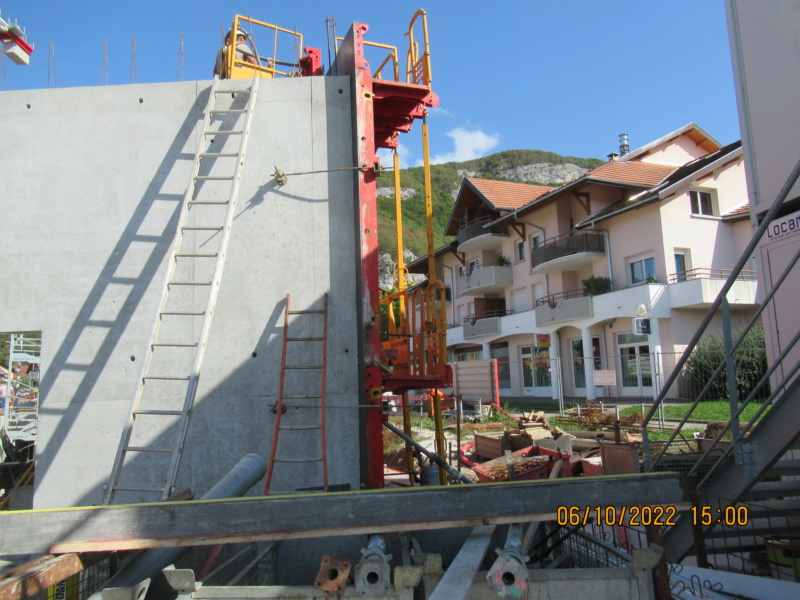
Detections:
[380, 280, 447, 377]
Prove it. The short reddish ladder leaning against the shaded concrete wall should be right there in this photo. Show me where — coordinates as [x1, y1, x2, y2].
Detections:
[264, 293, 328, 495]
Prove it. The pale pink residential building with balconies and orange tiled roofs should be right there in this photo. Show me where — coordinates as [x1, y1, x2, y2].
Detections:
[410, 123, 757, 399]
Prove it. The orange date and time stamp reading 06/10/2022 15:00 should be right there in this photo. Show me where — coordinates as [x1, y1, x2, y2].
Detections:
[556, 506, 750, 527]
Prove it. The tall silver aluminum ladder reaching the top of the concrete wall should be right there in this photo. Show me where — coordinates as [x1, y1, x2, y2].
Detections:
[103, 77, 259, 504]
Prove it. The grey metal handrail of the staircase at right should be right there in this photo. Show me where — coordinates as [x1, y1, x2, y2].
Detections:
[642, 156, 800, 482]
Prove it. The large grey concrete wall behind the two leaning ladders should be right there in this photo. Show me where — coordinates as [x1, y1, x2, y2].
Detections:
[0, 77, 361, 508]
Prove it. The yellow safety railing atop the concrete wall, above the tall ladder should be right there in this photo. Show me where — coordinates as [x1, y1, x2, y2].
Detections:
[225, 15, 303, 79]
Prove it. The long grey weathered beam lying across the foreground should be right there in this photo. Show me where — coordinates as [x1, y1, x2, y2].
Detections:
[0, 473, 689, 555]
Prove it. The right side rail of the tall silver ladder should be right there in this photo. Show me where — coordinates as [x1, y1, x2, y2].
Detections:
[162, 77, 259, 500]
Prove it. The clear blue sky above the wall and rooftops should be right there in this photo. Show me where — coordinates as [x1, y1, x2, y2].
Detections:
[0, 0, 740, 165]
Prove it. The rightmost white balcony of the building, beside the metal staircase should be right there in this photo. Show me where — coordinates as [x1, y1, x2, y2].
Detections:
[668, 269, 759, 310]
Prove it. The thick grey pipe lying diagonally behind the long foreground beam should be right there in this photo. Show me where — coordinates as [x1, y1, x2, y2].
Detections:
[89, 454, 267, 600]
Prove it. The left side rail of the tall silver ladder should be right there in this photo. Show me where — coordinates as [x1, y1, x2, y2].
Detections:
[103, 76, 220, 504]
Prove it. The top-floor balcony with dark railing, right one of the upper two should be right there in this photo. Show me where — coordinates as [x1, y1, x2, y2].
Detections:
[531, 230, 606, 273]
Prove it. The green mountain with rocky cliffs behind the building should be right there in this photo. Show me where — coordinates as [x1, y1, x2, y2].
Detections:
[378, 150, 603, 287]
